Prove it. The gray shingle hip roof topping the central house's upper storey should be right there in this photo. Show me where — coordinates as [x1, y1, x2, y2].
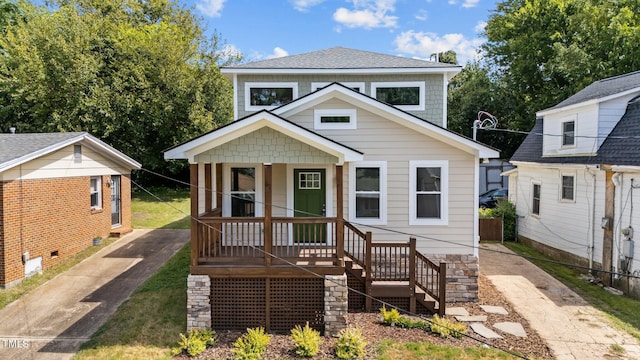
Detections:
[222, 47, 459, 71]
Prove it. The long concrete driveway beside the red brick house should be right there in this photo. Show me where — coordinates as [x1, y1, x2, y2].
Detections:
[0, 230, 189, 360]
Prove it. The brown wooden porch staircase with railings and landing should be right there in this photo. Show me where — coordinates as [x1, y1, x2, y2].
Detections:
[345, 224, 446, 316]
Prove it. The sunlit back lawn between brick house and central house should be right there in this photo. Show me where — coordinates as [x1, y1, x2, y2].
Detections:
[131, 187, 191, 229]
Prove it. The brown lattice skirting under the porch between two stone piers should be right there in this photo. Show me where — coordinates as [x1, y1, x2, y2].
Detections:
[211, 278, 324, 333]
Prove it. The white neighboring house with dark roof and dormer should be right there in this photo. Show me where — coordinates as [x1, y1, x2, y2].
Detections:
[505, 71, 640, 295]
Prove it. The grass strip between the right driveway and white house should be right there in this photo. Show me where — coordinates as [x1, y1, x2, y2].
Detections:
[504, 242, 640, 340]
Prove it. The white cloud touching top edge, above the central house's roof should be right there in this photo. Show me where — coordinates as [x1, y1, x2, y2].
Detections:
[333, 0, 398, 29]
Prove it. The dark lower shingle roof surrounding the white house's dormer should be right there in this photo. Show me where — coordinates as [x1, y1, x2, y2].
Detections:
[511, 97, 640, 166]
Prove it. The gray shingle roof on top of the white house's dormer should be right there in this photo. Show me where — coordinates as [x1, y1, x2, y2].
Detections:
[543, 71, 640, 111]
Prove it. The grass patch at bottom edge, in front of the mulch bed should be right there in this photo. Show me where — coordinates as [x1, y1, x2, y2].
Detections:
[377, 340, 517, 360]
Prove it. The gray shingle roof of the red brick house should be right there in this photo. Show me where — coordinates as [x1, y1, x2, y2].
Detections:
[0, 132, 86, 165]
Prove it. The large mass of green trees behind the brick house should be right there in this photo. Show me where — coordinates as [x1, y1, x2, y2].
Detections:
[0, 0, 238, 183]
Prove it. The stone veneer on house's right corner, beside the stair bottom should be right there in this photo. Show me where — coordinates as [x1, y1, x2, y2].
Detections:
[427, 254, 480, 303]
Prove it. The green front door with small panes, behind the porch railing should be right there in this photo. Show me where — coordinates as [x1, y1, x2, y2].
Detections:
[293, 169, 327, 243]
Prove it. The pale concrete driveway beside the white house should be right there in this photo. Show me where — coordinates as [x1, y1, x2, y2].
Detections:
[480, 243, 640, 360]
